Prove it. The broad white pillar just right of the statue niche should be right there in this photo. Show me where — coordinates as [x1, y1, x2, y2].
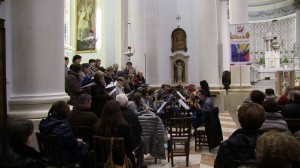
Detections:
[198, 0, 220, 87]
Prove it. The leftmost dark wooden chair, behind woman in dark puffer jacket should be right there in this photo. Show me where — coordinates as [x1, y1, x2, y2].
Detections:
[36, 132, 75, 167]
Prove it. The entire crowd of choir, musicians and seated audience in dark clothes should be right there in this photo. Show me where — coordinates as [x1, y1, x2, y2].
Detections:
[0, 55, 300, 168]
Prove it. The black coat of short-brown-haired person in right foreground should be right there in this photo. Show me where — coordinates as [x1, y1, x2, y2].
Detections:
[214, 129, 260, 168]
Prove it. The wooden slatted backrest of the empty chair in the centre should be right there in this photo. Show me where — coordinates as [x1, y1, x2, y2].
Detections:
[170, 117, 192, 140]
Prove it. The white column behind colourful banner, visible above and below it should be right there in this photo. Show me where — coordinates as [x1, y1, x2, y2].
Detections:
[229, 0, 251, 87]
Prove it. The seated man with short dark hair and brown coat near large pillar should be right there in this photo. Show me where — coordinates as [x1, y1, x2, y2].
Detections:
[67, 94, 99, 130]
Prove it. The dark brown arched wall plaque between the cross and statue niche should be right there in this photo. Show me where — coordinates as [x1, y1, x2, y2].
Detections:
[171, 27, 187, 52]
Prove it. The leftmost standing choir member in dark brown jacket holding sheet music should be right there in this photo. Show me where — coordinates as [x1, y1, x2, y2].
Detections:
[67, 64, 86, 106]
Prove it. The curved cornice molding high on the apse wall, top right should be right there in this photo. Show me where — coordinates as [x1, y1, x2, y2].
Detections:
[248, 5, 296, 21]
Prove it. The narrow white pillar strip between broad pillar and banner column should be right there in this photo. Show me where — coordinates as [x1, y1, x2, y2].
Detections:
[219, 0, 230, 71]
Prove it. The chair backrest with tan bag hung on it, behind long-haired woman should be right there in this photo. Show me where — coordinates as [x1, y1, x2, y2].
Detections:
[93, 135, 125, 167]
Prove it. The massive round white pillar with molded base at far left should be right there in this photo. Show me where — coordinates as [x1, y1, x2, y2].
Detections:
[8, 0, 69, 119]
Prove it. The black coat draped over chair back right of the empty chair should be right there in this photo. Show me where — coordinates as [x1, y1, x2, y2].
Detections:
[205, 107, 223, 149]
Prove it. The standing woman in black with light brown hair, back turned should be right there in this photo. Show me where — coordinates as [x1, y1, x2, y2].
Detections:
[91, 71, 111, 117]
